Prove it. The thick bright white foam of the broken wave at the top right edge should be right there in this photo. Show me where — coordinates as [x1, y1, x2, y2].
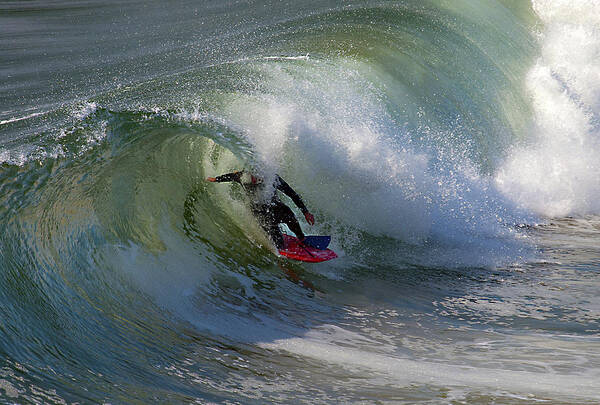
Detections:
[496, 0, 600, 217]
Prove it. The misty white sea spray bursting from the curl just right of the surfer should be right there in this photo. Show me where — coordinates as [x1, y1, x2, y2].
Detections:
[217, 57, 531, 266]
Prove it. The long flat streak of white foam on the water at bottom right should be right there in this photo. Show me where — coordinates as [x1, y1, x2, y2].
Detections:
[261, 325, 600, 398]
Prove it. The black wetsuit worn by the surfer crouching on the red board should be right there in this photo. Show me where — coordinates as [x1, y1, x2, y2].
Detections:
[215, 171, 308, 249]
